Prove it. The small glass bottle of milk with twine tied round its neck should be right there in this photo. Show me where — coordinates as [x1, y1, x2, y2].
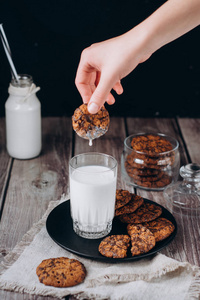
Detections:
[5, 75, 42, 159]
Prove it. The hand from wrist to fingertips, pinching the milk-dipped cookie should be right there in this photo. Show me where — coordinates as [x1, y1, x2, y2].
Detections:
[75, 29, 150, 113]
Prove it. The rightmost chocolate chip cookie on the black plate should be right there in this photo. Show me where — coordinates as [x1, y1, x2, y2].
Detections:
[143, 218, 175, 242]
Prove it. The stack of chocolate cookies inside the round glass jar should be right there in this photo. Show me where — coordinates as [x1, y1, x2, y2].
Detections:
[125, 134, 175, 189]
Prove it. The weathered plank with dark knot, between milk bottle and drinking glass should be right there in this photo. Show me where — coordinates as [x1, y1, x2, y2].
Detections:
[0, 118, 72, 255]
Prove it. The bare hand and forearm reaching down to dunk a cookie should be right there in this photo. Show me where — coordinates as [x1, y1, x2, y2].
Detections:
[75, 0, 200, 113]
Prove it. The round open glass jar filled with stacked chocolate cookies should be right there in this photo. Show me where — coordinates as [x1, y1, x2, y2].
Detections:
[121, 133, 180, 191]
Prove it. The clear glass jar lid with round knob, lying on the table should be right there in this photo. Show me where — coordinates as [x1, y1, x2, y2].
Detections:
[164, 163, 200, 214]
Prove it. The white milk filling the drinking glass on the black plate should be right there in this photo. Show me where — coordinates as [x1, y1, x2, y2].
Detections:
[70, 165, 116, 233]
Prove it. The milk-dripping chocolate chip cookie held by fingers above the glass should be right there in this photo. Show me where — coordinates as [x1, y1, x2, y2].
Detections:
[72, 104, 110, 139]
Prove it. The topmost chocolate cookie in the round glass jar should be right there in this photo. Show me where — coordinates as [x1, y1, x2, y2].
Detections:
[131, 134, 172, 157]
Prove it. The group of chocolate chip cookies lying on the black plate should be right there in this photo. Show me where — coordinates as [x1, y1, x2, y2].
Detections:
[99, 189, 175, 258]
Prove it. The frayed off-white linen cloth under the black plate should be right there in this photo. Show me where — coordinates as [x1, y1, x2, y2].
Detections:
[0, 197, 200, 300]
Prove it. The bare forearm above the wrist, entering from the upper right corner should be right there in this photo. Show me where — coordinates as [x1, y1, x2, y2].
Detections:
[130, 0, 200, 55]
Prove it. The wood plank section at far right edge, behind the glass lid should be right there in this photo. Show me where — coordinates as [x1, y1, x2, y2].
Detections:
[178, 118, 200, 164]
